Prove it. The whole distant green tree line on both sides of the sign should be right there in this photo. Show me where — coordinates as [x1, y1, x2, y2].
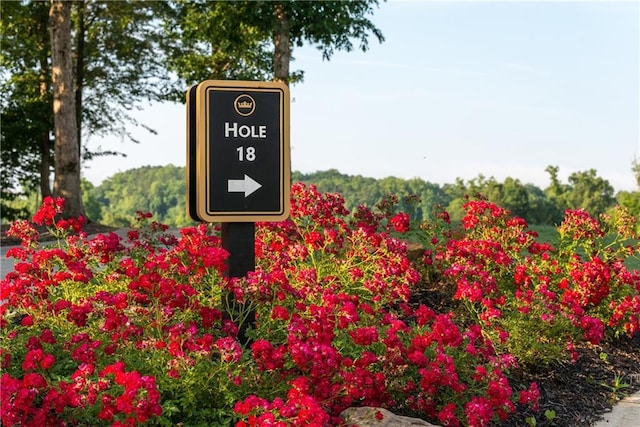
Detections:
[38, 162, 640, 231]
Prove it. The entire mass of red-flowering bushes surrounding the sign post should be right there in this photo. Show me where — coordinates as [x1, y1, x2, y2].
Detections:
[0, 188, 640, 426]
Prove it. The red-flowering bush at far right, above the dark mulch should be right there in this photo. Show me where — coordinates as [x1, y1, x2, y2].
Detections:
[425, 199, 640, 364]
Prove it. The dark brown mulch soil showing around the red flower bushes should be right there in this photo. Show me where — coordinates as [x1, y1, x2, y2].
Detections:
[0, 223, 640, 427]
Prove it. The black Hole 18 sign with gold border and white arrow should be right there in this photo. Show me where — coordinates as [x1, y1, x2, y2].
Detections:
[187, 80, 291, 222]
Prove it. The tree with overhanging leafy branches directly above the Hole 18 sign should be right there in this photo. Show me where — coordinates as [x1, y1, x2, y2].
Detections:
[165, 0, 384, 88]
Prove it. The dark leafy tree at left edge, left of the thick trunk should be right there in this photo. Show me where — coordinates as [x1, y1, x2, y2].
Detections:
[0, 2, 53, 220]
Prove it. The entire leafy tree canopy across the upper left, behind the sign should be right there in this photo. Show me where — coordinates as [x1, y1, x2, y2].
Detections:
[0, 0, 383, 218]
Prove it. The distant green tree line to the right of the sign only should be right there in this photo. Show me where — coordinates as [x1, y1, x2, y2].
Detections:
[292, 166, 640, 225]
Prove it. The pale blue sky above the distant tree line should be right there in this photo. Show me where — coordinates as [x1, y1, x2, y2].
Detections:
[83, 0, 640, 191]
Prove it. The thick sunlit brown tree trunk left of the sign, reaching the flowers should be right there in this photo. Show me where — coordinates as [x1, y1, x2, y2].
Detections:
[49, 0, 84, 217]
